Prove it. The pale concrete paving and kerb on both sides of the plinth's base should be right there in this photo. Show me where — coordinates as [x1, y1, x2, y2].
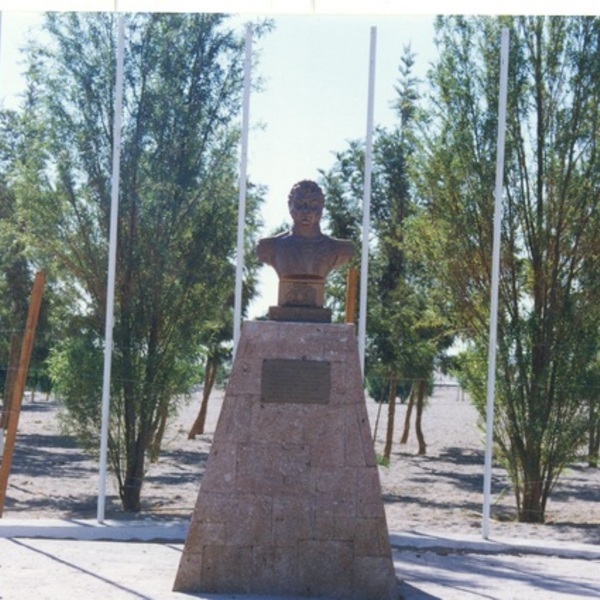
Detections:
[0, 520, 600, 600]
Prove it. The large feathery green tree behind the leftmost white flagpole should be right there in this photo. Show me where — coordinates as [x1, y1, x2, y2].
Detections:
[12, 13, 262, 511]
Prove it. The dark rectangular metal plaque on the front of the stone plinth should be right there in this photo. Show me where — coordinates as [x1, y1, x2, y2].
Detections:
[261, 358, 331, 404]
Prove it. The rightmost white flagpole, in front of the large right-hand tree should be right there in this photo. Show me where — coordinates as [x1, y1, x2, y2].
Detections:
[482, 28, 509, 539]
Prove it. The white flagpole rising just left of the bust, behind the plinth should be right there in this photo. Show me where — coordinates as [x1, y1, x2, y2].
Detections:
[233, 24, 252, 356]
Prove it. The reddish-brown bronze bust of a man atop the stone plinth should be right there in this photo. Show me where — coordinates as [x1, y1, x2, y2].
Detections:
[256, 180, 353, 321]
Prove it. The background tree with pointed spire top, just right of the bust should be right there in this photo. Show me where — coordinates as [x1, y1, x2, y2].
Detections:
[324, 47, 447, 460]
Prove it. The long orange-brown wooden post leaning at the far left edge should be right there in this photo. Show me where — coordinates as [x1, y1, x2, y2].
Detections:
[0, 271, 45, 517]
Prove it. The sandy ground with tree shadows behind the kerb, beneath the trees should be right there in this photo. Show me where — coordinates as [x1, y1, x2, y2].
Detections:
[0, 387, 600, 544]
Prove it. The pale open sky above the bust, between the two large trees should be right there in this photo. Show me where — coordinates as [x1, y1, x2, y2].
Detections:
[248, 16, 434, 230]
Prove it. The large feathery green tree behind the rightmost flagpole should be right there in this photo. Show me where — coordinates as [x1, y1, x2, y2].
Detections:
[419, 17, 600, 522]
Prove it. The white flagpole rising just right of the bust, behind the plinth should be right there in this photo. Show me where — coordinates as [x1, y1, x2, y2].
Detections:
[358, 27, 377, 377]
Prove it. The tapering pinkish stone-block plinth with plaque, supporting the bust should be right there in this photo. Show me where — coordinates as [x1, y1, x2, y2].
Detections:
[174, 321, 398, 600]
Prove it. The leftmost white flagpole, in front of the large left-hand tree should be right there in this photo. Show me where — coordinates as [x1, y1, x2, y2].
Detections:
[97, 14, 125, 523]
